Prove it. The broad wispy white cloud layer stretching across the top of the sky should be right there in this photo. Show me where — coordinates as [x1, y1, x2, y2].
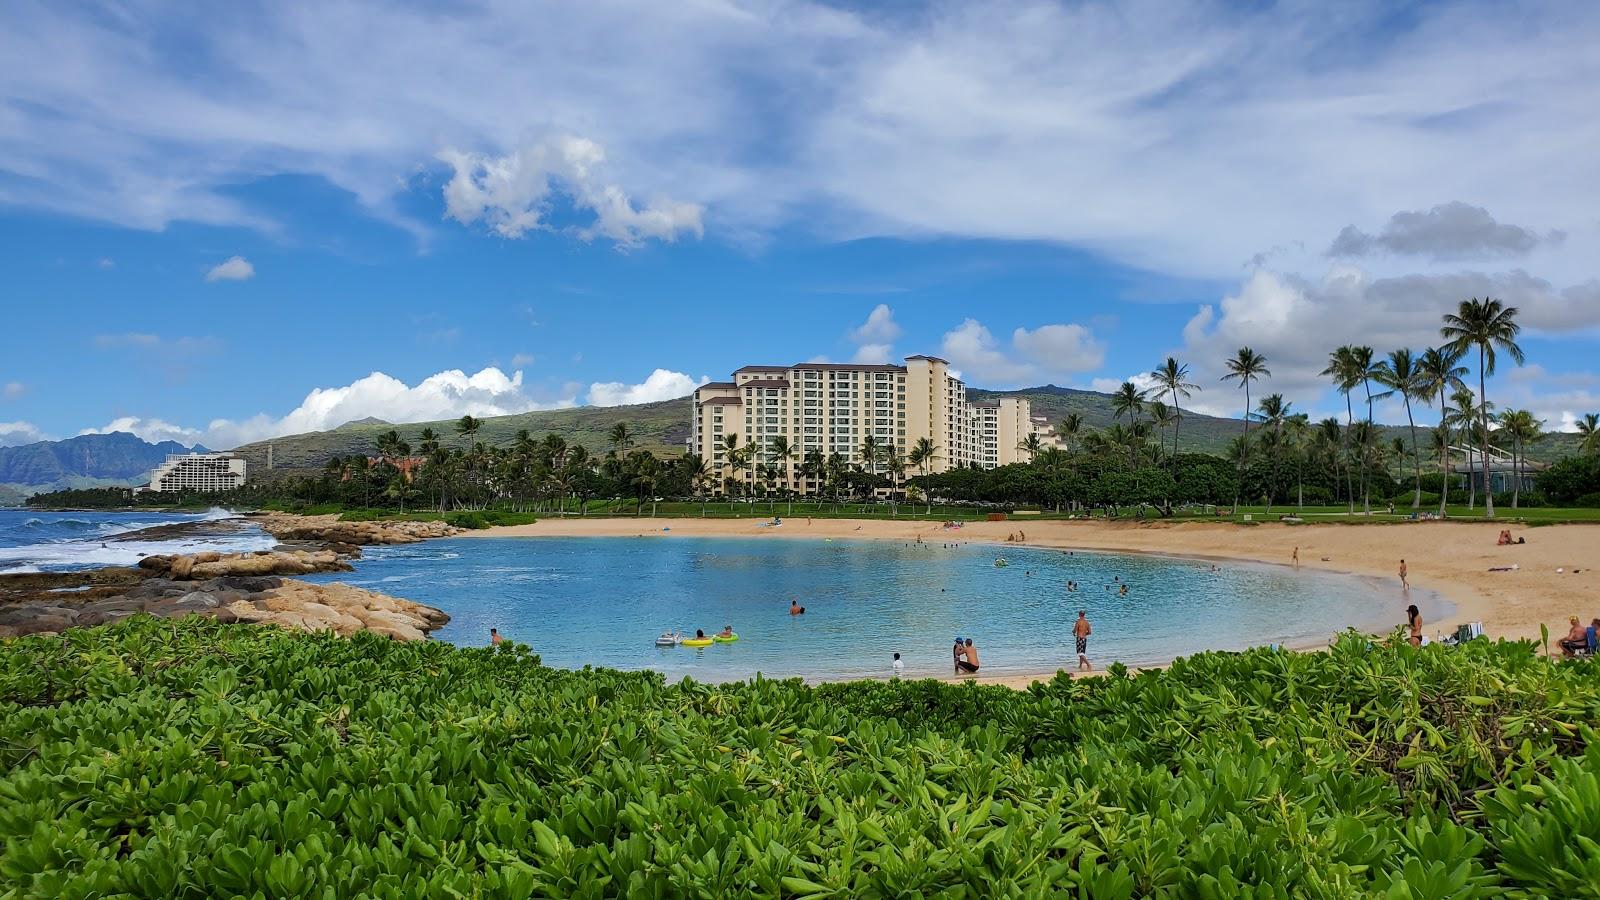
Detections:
[0, 0, 1600, 280]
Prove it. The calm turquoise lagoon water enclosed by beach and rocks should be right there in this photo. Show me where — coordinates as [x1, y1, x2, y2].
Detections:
[312, 536, 1448, 682]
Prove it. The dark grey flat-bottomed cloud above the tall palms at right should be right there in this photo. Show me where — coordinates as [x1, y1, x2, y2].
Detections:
[1328, 200, 1566, 261]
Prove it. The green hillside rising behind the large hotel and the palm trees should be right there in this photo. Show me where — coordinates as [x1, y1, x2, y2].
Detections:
[234, 384, 1578, 479]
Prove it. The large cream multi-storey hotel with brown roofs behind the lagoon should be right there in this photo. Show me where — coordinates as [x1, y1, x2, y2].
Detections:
[690, 356, 1056, 492]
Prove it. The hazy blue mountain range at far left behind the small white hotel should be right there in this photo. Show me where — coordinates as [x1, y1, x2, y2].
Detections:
[0, 431, 210, 503]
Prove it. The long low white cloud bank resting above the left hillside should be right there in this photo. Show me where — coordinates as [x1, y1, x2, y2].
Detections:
[82, 367, 576, 448]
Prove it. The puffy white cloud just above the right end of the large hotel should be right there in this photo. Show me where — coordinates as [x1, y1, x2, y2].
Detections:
[939, 319, 1106, 386]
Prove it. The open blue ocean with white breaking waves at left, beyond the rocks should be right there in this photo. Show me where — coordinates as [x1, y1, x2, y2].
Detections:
[0, 509, 277, 573]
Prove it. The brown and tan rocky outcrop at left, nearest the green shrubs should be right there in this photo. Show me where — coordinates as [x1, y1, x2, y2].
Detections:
[0, 551, 450, 641]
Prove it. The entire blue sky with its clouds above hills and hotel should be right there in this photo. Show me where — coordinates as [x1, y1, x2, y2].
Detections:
[0, 2, 1600, 447]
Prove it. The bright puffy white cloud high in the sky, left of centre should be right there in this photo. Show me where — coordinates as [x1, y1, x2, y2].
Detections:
[438, 135, 706, 247]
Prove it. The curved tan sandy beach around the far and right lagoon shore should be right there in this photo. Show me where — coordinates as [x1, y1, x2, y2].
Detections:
[469, 516, 1600, 685]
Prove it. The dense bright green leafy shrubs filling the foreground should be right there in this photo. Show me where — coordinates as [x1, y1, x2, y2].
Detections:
[0, 618, 1600, 898]
